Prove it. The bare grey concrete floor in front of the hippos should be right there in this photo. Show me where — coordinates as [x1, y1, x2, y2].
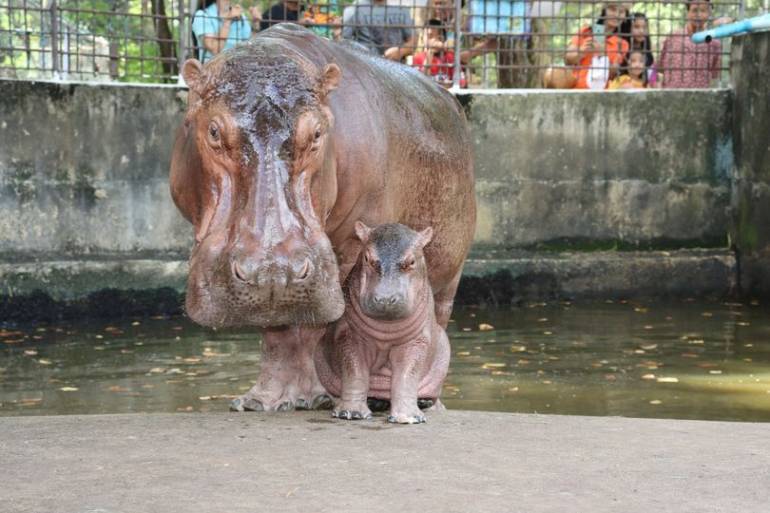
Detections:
[0, 411, 770, 513]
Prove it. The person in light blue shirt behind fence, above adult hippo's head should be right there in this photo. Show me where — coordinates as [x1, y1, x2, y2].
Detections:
[192, 0, 251, 62]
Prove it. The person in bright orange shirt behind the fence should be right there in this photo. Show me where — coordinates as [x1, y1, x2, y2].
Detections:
[543, 2, 628, 89]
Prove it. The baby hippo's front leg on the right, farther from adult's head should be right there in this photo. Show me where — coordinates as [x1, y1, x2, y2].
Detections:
[388, 340, 428, 424]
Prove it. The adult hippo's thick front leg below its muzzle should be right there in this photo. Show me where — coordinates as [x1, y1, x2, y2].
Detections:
[230, 327, 331, 411]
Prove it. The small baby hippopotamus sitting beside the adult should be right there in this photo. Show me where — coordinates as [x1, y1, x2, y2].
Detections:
[315, 221, 450, 424]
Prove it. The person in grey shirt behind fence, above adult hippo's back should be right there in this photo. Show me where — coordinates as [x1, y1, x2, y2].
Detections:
[342, 0, 415, 61]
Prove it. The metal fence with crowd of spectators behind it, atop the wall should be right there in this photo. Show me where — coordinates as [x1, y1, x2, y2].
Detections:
[0, 0, 768, 89]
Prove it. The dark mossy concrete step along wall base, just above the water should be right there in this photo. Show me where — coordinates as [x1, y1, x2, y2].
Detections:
[0, 249, 737, 321]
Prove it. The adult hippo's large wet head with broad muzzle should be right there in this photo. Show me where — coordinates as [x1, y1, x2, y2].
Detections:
[171, 40, 344, 327]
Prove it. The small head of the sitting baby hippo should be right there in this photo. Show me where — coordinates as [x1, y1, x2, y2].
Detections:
[355, 221, 433, 321]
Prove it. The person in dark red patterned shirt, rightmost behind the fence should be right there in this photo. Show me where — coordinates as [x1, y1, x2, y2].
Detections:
[658, 0, 722, 88]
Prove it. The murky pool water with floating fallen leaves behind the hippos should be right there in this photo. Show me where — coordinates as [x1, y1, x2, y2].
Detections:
[0, 301, 770, 421]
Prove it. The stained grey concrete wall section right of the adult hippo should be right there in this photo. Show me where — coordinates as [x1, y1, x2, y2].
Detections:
[463, 90, 733, 248]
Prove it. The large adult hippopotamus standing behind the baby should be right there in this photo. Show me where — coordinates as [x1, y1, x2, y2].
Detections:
[170, 24, 476, 411]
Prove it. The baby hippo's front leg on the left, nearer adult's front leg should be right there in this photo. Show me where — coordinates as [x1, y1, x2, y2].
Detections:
[332, 337, 372, 420]
